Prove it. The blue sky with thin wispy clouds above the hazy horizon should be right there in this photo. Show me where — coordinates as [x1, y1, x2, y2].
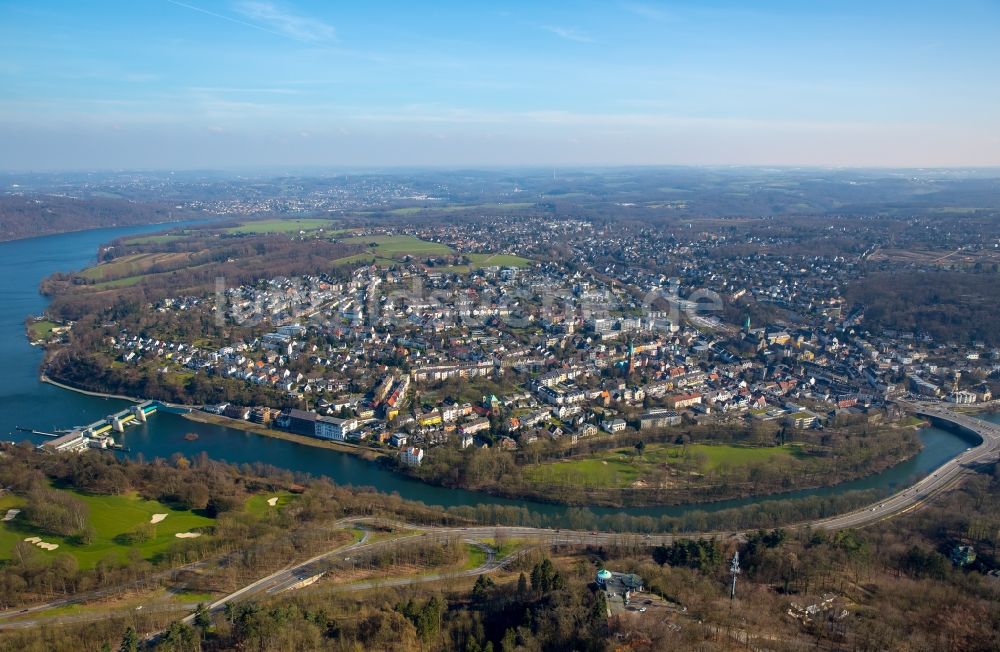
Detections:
[0, 0, 1000, 171]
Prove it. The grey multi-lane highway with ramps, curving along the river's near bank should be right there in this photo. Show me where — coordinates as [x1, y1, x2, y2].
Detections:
[0, 401, 1000, 629]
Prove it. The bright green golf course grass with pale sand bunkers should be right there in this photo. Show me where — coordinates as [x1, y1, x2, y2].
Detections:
[0, 490, 215, 568]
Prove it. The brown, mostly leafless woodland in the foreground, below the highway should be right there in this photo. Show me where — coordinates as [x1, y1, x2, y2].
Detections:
[7, 460, 1000, 652]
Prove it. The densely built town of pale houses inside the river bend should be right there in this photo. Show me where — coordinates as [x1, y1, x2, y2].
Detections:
[62, 211, 1000, 496]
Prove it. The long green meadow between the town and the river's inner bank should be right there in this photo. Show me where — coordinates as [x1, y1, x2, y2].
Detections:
[524, 444, 800, 488]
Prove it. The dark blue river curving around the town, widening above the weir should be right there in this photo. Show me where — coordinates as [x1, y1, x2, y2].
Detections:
[0, 225, 998, 519]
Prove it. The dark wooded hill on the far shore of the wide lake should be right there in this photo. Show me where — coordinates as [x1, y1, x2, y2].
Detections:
[0, 195, 186, 241]
